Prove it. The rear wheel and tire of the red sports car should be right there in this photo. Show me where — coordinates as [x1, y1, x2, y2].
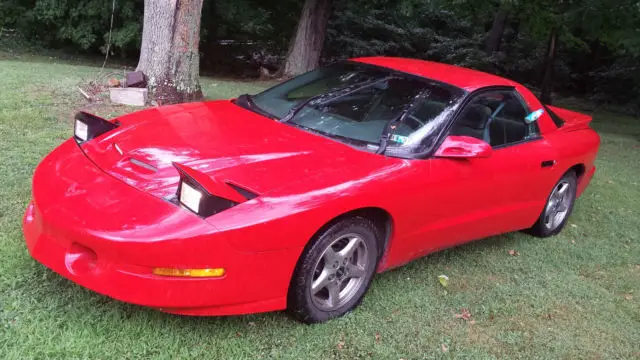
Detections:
[529, 171, 578, 237]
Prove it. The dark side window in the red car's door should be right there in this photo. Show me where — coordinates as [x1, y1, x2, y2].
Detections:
[450, 90, 537, 147]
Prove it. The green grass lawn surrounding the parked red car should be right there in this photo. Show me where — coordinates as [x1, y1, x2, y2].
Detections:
[0, 59, 640, 360]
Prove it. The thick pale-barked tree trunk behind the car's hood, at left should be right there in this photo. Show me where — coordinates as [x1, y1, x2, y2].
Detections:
[136, 0, 202, 104]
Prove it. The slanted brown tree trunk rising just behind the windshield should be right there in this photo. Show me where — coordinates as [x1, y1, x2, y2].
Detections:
[280, 0, 331, 77]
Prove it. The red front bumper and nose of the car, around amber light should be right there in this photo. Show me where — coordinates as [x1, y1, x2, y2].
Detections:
[23, 143, 300, 315]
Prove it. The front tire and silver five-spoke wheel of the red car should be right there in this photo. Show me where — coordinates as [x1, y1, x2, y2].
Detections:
[287, 217, 380, 324]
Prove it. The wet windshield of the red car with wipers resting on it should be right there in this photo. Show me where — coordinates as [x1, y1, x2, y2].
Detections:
[252, 62, 464, 155]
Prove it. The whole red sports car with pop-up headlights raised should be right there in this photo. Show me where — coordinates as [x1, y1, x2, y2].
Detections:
[24, 57, 600, 323]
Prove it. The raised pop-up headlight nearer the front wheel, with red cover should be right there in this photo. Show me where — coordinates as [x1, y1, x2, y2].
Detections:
[173, 163, 258, 218]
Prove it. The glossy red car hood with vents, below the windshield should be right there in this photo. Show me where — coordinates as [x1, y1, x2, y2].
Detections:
[81, 101, 382, 198]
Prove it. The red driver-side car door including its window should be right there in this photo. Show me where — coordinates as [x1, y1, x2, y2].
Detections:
[408, 88, 554, 254]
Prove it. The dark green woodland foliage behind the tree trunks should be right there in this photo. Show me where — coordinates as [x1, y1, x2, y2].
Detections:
[0, 0, 640, 112]
